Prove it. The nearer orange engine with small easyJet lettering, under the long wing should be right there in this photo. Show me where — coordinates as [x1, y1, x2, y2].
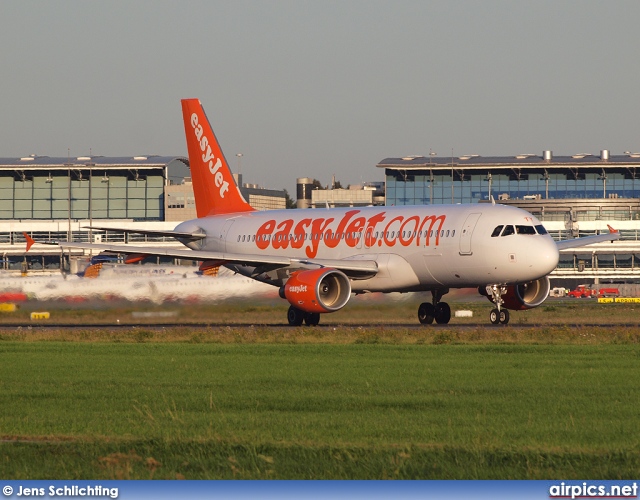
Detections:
[280, 269, 351, 313]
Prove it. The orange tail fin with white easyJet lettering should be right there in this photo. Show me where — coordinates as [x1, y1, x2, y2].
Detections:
[182, 99, 253, 217]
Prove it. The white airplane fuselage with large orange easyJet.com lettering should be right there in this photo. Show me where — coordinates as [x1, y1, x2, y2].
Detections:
[176, 204, 559, 292]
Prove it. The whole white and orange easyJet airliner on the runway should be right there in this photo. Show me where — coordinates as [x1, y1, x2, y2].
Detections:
[26, 99, 619, 325]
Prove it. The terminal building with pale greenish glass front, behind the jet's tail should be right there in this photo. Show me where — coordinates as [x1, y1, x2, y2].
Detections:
[0, 156, 286, 272]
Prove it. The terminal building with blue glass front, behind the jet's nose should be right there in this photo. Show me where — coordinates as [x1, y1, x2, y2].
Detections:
[377, 150, 640, 286]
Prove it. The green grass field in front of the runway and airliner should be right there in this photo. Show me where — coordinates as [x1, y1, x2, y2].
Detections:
[0, 304, 640, 479]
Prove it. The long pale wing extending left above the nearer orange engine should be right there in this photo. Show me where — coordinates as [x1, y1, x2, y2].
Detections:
[46, 241, 378, 279]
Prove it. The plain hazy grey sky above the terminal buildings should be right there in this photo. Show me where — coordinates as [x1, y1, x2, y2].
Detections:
[0, 0, 640, 198]
